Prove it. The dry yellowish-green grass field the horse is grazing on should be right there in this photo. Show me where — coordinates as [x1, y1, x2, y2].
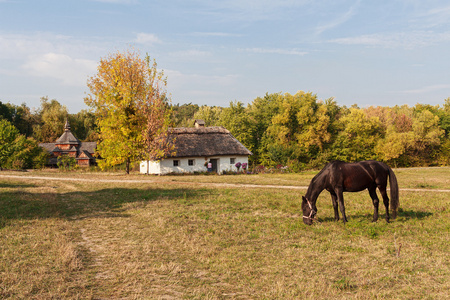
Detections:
[0, 168, 450, 299]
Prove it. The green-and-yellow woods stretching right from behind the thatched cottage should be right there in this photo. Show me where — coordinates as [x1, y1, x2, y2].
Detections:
[172, 91, 450, 172]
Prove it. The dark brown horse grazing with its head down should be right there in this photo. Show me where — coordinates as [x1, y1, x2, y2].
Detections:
[302, 160, 399, 225]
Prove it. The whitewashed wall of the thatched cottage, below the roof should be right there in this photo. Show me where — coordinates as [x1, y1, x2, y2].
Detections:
[140, 156, 248, 175]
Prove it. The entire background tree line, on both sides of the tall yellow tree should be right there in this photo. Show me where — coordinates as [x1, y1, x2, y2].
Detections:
[0, 91, 450, 172]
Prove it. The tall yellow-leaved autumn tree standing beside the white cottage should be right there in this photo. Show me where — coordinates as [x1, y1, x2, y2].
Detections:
[85, 51, 173, 174]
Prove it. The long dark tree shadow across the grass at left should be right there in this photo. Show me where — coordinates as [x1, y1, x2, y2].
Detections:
[0, 184, 211, 228]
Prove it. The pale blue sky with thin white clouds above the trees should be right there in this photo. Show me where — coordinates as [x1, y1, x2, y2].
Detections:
[0, 0, 450, 113]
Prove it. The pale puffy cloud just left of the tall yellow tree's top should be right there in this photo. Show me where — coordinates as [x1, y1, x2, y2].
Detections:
[22, 53, 97, 86]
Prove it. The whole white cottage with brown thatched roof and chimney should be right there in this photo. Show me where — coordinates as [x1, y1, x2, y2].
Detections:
[140, 120, 252, 175]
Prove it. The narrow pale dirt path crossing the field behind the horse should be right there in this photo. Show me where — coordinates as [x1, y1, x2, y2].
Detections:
[0, 174, 450, 193]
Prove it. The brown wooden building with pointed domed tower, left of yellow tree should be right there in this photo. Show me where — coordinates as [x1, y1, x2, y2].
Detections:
[39, 121, 97, 167]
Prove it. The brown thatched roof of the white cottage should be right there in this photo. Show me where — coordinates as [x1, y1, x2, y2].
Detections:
[169, 127, 252, 157]
